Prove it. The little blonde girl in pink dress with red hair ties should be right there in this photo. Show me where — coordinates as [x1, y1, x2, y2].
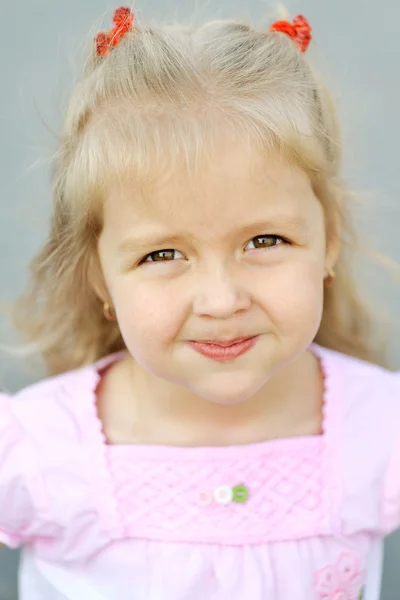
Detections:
[0, 8, 400, 600]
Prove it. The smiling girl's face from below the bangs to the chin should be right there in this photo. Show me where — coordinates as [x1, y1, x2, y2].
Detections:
[99, 144, 332, 404]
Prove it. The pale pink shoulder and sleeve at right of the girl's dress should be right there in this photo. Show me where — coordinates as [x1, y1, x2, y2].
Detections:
[316, 348, 400, 533]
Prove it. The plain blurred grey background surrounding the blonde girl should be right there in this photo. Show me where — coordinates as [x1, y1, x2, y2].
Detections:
[0, 0, 400, 600]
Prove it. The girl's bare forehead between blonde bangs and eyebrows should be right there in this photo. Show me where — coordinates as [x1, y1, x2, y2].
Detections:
[104, 143, 319, 231]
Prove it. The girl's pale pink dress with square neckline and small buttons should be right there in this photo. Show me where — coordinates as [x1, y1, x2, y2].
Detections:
[0, 346, 400, 600]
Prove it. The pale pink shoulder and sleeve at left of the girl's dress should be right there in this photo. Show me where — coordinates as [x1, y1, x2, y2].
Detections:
[0, 361, 120, 547]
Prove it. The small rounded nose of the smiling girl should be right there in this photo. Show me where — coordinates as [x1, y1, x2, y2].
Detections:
[193, 268, 251, 319]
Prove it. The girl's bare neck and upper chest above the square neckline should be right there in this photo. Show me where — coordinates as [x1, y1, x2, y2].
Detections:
[108, 351, 323, 446]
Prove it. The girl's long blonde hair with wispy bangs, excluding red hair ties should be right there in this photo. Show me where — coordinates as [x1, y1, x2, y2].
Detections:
[15, 11, 394, 374]
